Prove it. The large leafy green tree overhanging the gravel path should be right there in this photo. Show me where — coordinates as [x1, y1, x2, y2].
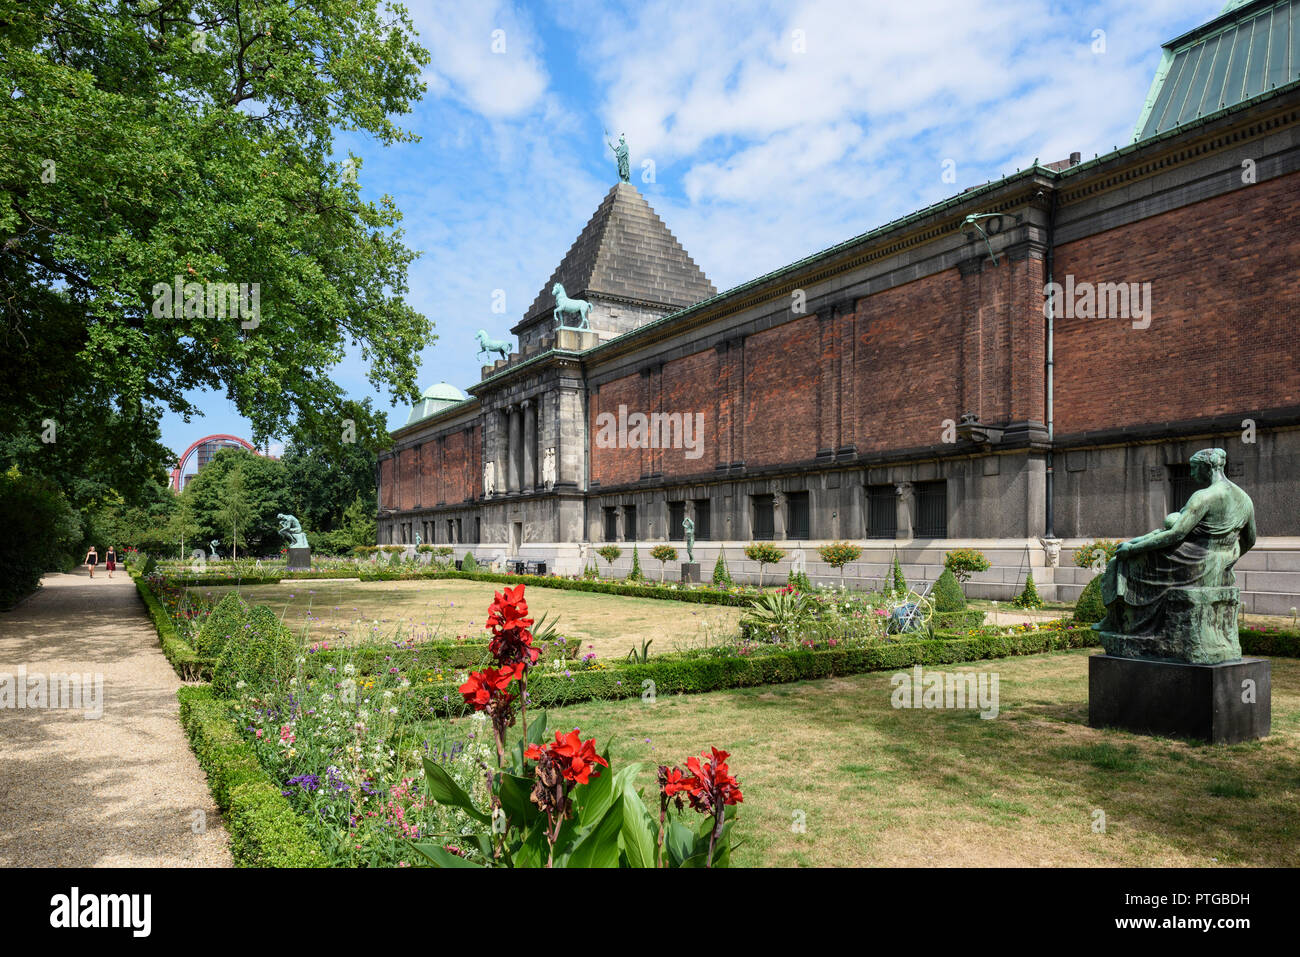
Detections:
[0, 0, 432, 503]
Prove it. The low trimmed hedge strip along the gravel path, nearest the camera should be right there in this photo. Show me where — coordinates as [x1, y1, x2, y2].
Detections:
[177, 687, 329, 867]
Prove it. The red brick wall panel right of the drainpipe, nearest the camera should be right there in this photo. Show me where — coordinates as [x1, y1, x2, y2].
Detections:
[1054, 173, 1300, 434]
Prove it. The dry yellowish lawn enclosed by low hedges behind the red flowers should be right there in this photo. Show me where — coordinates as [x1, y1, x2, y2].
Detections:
[195, 579, 741, 658]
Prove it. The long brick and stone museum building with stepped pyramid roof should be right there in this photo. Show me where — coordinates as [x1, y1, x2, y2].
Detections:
[377, 0, 1300, 614]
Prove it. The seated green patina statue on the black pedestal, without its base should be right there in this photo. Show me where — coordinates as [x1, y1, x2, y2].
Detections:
[1093, 449, 1256, 664]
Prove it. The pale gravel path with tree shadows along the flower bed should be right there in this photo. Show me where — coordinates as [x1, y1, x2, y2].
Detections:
[0, 568, 230, 867]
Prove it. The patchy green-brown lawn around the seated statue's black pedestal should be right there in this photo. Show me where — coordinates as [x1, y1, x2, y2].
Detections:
[509, 651, 1300, 867]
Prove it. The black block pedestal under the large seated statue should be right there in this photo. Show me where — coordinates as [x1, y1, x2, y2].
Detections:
[1088, 654, 1273, 744]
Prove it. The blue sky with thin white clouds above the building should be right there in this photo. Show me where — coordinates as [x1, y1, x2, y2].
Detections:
[154, 0, 1223, 468]
